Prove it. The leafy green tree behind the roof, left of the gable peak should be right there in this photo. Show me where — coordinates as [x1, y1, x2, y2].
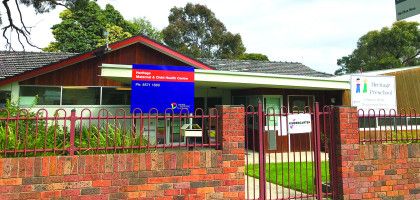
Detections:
[43, 1, 160, 53]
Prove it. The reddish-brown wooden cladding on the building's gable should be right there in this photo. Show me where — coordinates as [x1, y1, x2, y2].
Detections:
[19, 43, 190, 86]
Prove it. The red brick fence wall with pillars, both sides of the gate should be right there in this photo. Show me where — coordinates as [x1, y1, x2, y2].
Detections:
[0, 106, 420, 199]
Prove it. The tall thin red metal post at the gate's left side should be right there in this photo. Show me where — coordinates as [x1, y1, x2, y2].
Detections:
[258, 100, 266, 199]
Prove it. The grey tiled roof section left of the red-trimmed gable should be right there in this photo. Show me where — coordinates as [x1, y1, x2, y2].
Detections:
[0, 51, 77, 80]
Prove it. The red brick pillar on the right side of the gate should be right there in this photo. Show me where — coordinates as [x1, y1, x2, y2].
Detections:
[333, 107, 362, 199]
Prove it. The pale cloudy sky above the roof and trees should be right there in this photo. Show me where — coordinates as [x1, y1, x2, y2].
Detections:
[0, 0, 420, 73]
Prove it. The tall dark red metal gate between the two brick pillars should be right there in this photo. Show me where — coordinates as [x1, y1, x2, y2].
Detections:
[245, 103, 337, 199]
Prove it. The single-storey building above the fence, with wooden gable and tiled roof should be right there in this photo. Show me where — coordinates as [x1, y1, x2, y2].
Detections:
[0, 36, 350, 151]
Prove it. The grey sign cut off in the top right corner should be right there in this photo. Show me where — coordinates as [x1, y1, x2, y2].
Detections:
[395, 0, 420, 20]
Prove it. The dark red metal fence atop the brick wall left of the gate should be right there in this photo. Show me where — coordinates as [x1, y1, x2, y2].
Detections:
[0, 108, 219, 157]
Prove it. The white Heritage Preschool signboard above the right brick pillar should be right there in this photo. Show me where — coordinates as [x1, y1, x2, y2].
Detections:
[350, 75, 397, 114]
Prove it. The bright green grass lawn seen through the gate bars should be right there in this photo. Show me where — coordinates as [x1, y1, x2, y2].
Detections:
[246, 162, 329, 194]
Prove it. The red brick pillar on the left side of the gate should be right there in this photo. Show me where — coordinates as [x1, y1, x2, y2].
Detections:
[217, 105, 245, 199]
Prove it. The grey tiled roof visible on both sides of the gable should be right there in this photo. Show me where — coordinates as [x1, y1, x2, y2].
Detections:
[0, 51, 333, 80]
